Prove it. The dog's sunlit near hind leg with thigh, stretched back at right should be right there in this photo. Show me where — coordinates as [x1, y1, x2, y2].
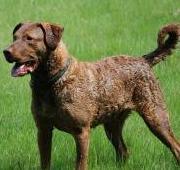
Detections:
[133, 70, 180, 162]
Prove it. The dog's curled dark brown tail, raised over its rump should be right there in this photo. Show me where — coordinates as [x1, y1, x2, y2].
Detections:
[143, 24, 180, 67]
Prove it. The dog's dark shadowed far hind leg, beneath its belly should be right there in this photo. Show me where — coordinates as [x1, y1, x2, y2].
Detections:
[104, 112, 128, 161]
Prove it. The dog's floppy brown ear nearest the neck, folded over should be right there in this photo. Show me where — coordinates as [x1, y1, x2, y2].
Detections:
[40, 23, 64, 50]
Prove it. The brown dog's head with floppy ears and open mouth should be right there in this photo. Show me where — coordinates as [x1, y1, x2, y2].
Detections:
[3, 23, 63, 77]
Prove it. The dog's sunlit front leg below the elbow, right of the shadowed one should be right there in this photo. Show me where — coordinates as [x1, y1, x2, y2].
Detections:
[74, 127, 90, 170]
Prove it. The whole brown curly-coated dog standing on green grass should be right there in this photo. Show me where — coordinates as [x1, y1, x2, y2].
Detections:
[4, 23, 180, 170]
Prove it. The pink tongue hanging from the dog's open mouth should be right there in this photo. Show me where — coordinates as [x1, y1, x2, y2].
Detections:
[11, 64, 32, 77]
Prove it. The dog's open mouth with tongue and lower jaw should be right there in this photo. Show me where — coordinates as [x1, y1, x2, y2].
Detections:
[11, 60, 37, 77]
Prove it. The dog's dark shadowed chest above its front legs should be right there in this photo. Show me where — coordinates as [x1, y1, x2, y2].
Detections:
[32, 86, 87, 132]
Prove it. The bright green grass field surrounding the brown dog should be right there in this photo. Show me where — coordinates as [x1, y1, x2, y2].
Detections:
[0, 0, 180, 170]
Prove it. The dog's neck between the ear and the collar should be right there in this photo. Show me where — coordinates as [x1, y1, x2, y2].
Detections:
[31, 41, 70, 86]
